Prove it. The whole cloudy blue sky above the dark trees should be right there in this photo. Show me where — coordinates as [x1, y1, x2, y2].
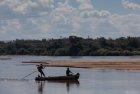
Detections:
[0, 0, 140, 40]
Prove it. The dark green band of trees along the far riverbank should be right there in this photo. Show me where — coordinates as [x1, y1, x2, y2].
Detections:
[0, 36, 140, 56]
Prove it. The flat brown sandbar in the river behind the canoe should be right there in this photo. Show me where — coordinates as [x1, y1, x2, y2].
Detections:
[23, 59, 140, 70]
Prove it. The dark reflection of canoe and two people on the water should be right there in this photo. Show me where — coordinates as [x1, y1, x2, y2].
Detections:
[36, 80, 80, 94]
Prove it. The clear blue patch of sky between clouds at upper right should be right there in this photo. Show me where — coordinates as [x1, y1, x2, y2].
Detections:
[92, 0, 140, 14]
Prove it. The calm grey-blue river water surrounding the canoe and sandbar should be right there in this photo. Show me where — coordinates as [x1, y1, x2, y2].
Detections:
[0, 56, 140, 94]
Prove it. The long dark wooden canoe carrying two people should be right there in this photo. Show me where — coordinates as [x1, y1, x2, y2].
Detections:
[35, 73, 80, 81]
